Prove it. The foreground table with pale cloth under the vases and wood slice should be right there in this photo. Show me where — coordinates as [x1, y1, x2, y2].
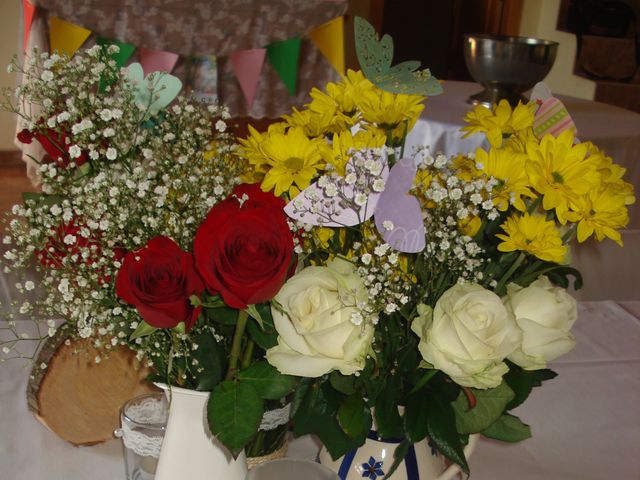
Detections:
[0, 301, 640, 480]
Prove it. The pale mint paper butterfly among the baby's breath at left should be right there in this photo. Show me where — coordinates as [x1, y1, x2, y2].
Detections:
[127, 63, 182, 118]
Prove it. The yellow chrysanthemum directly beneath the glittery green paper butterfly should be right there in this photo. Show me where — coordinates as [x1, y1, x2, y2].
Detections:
[355, 88, 425, 140]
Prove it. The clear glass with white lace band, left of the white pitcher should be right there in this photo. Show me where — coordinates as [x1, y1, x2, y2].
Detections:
[114, 393, 169, 480]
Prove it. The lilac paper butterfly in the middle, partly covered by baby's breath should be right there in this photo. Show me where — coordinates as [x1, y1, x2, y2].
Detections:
[284, 154, 425, 253]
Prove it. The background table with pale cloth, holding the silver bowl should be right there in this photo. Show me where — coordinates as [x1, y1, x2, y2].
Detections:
[406, 80, 640, 229]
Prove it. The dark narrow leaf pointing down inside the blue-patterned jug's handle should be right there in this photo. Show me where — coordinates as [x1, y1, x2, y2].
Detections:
[424, 395, 469, 474]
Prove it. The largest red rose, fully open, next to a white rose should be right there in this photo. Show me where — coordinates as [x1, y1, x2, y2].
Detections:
[193, 184, 293, 309]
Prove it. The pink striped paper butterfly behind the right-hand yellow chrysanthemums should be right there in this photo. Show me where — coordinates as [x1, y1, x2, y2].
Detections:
[531, 82, 578, 138]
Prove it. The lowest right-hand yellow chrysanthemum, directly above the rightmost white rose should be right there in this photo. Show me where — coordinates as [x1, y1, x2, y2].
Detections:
[496, 213, 567, 263]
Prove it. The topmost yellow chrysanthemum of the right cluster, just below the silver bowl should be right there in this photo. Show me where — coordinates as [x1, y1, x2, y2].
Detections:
[462, 100, 536, 147]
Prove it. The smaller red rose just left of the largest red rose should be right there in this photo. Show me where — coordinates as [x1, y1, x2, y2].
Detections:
[116, 237, 204, 331]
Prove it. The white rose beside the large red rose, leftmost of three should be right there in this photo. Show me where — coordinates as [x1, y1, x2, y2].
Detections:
[266, 259, 373, 377]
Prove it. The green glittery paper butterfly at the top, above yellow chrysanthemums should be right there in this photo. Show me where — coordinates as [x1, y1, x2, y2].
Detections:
[355, 17, 442, 96]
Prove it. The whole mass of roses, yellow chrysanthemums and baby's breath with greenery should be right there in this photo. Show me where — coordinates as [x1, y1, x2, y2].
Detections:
[5, 18, 634, 478]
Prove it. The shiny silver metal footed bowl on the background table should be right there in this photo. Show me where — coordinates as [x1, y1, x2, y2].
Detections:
[464, 34, 558, 107]
